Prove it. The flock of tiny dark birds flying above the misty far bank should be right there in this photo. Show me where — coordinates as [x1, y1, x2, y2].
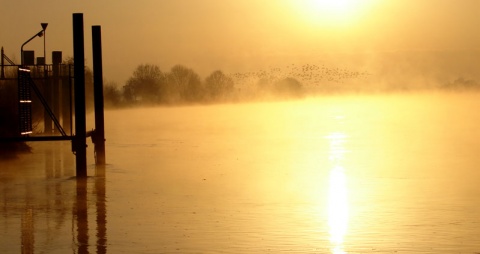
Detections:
[230, 64, 370, 89]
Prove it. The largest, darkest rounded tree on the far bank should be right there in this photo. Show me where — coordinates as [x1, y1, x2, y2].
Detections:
[124, 64, 165, 103]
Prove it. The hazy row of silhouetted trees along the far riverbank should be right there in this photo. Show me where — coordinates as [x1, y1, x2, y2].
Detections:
[104, 64, 303, 107]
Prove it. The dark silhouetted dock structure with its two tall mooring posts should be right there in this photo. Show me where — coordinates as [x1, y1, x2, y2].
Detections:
[0, 13, 105, 178]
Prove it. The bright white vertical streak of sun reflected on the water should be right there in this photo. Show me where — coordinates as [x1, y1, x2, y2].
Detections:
[326, 132, 349, 254]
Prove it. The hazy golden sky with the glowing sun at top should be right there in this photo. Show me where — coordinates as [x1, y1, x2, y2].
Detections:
[0, 0, 480, 85]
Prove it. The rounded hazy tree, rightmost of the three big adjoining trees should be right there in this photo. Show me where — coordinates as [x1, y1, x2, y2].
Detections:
[205, 70, 233, 100]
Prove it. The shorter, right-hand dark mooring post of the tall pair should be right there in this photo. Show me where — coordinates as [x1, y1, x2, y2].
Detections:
[92, 26, 105, 165]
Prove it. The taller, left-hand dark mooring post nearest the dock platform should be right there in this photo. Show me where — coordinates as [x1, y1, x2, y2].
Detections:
[73, 13, 87, 177]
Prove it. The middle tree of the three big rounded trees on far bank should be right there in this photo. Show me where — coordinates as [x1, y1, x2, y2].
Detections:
[167, 65, 203, 102]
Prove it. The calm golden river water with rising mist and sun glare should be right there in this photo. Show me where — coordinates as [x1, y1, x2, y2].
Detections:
[0, 93, 480, 253]
